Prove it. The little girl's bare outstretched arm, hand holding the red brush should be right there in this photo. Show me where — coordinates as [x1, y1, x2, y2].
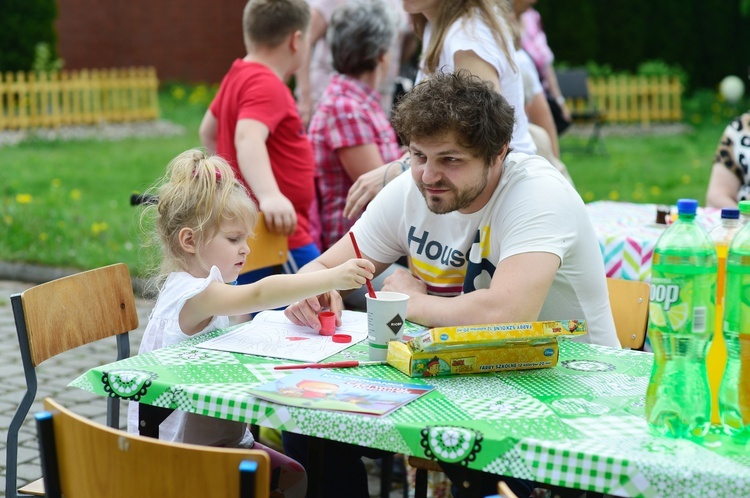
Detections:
[180, 259, 375, 335]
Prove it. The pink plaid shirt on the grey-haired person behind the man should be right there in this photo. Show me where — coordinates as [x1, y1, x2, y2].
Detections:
[308, 74, 401, 250]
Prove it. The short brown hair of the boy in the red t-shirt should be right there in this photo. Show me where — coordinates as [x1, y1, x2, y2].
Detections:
[242, 0, 310, 47]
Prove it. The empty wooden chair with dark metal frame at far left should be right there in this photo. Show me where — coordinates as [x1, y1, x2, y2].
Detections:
[5, 263, 138, 498]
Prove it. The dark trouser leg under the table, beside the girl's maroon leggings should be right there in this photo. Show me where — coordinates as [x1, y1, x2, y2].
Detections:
[281, 432, 388, 498]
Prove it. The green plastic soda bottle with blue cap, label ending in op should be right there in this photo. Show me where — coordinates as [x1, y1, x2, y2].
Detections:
[646, 199, 717, 438]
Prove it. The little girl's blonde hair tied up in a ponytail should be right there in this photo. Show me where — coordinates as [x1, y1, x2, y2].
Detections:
[141, 149, 258, 287]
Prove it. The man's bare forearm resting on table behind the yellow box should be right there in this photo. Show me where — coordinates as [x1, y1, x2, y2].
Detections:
[383, 252, 560, 327]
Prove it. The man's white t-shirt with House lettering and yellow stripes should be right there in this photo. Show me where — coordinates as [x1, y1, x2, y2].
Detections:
[352, 153, 620, 347]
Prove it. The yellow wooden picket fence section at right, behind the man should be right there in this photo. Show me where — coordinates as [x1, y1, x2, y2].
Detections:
[568, 76, 682, 126]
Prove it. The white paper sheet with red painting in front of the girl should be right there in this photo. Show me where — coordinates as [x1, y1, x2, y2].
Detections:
[198, 310, 367, 363]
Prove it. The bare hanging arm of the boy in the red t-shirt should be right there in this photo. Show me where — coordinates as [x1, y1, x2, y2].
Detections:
[234, 119, 297, 235]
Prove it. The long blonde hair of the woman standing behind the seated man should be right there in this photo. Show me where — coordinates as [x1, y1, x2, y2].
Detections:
[411, 0, 516, 74]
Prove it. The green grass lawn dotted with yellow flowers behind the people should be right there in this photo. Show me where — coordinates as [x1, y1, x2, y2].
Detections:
[0, 82, 744, 275]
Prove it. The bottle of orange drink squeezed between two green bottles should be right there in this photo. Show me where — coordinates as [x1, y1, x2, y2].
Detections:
[706, 208, 740, 424]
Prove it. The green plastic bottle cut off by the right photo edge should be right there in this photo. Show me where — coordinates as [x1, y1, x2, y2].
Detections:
[719, 216, 750, 444]
